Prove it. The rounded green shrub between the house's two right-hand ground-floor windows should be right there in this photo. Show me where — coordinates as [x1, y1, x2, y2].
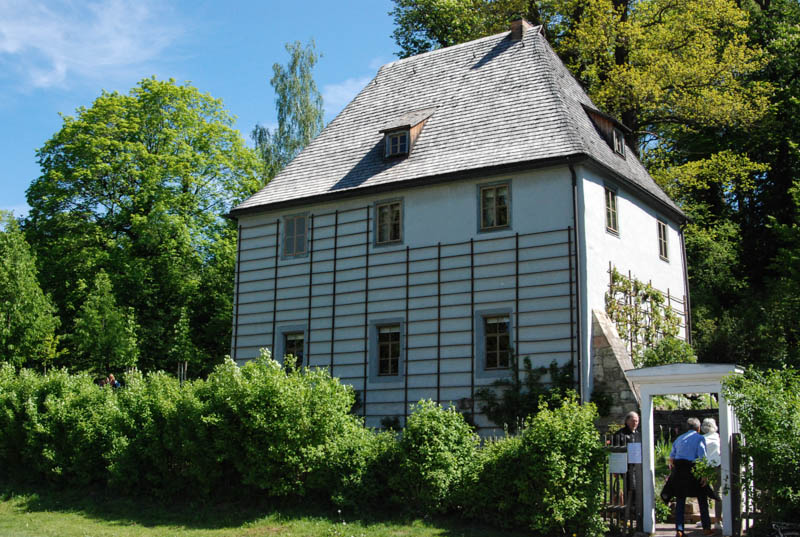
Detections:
[389, 400, 478, 513]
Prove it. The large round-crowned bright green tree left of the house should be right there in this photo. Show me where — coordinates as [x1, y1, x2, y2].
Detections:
[25, 78, 260, 370]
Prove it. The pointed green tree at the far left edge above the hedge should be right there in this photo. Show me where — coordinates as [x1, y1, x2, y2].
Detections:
[0, 211, 59, 368]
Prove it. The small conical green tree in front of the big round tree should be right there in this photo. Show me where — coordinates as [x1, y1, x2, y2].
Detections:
[70, 270, 139, 376]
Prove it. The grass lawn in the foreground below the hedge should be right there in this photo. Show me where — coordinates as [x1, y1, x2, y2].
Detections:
[0, 483, 525, 537]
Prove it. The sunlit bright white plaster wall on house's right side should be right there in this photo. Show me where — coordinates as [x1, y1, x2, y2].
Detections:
[576, 166, 687, 395]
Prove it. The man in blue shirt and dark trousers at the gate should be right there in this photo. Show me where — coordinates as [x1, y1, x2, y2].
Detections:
[669, 418, 714, 537]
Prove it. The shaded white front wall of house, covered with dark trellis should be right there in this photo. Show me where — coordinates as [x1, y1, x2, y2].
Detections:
[232, 167, 588, 426]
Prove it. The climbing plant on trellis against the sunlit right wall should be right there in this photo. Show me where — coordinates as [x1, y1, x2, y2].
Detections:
[606, 267, 680, 361]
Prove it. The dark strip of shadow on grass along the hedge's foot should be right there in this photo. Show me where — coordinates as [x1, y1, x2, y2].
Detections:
[0, 480, 530, 537]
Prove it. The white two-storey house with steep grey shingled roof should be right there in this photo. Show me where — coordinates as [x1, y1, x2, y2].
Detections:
[231, 21, 687, 427]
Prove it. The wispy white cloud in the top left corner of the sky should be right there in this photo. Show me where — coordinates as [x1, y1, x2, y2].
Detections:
[0, 0, 181, 87]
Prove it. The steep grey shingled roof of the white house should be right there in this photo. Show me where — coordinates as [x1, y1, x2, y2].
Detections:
[231, 27, 683, 217]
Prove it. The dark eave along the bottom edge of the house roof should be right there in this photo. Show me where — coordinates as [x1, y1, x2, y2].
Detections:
[225, 153, 686, 223]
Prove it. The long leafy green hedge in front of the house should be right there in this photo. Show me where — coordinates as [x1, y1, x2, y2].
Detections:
[0, 355, 603, 535]
